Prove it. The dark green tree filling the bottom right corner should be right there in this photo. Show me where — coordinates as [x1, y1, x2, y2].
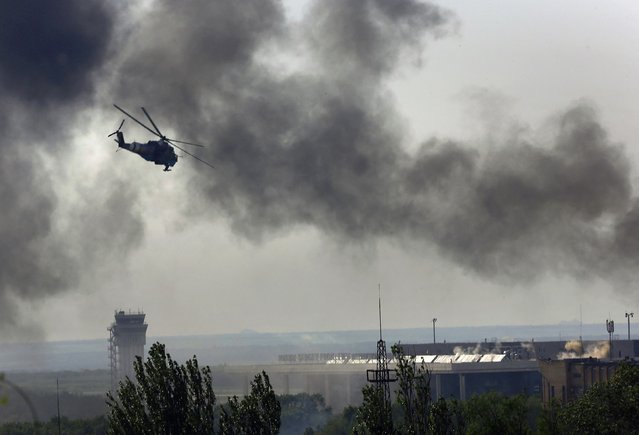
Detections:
[558, 363, 639, 434]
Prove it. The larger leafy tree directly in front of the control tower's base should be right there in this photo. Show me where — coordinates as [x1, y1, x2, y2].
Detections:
[107, 343, 215, 435]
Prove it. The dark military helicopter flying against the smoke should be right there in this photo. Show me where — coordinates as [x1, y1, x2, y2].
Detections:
[107, 104, 214, 172]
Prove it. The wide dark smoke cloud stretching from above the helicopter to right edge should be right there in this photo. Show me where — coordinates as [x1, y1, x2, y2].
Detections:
[111, 0, 639, 288]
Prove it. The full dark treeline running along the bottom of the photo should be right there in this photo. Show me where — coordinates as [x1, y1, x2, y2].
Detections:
[0, 343, 639, 435]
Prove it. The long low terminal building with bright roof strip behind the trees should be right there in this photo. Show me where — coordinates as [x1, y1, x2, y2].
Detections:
[214, 340, 639, 410]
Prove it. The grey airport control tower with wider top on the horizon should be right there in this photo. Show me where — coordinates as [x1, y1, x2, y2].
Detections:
[107, 310, 148, 391]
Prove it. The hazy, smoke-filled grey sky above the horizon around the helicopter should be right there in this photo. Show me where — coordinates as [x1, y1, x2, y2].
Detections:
[0, 0, 639, 341]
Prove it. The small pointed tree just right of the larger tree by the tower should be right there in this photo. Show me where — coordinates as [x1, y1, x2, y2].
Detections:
[220, 371, 281, 435]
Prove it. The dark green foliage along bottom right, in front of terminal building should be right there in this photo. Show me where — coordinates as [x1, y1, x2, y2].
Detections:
[324, 360, 639, 435]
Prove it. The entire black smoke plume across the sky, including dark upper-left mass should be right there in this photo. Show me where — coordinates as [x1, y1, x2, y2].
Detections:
[0, 0, 639, 338]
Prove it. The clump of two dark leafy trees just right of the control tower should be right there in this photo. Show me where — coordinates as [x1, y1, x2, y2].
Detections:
[107, 343, 280, 435]
